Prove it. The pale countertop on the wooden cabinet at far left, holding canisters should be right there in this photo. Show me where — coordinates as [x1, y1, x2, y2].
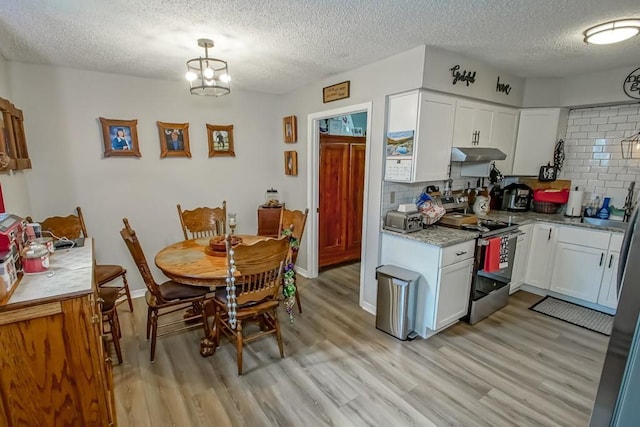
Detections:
[0, 238, 93, 311]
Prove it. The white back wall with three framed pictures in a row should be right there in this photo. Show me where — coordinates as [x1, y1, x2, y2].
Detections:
[9, 63, 284, 288]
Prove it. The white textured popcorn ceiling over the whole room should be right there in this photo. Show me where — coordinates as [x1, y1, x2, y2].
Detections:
[0, 0, 640, 93]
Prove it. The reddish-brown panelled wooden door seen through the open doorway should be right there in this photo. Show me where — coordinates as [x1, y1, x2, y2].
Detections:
[318, 135, 365, 267]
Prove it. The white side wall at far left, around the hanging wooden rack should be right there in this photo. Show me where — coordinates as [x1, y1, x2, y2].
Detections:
[0, 55, 31, 216]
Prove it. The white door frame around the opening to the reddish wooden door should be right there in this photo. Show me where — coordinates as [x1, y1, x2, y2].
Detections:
[307, 102, 373, 304]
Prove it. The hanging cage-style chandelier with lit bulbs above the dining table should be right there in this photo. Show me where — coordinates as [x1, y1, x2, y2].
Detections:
[185, 39, 231, 96]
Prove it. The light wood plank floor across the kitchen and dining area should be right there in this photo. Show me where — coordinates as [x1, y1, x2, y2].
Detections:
[114, 264, 608, 427]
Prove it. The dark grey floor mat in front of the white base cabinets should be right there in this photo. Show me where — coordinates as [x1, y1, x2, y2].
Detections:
[529, 297, 613, 336]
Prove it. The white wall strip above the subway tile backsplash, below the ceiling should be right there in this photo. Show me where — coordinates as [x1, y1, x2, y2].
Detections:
[522, 67, 638, 108]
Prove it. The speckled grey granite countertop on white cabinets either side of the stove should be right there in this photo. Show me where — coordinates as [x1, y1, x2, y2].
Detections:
[382, 211, 624, 247]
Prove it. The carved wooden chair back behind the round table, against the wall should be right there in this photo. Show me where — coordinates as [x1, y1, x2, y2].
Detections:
[178, 200, 227, 240]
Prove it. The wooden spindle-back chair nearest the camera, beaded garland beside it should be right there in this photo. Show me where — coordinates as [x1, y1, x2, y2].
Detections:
[213, 238, 289, 375]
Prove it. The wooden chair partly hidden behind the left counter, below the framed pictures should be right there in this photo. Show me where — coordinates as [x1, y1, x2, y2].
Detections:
[27, 207, 133, 311]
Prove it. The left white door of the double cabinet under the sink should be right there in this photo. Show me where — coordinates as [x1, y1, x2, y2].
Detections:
[550, 242, 606, 303]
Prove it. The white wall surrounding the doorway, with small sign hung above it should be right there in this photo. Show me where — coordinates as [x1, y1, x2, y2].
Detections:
[281, 46, 425, 308]
